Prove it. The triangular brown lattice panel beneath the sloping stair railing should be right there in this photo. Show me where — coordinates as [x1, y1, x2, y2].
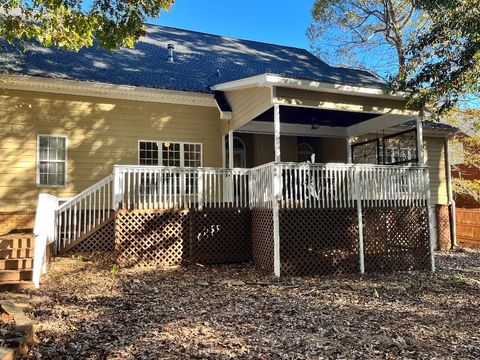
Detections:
[66, 216, 115, 253]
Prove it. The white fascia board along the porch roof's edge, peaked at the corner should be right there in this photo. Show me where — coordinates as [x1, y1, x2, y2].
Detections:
[211, 74, 408, 100]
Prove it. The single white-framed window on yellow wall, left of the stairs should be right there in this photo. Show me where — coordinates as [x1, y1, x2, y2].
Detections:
[37, 135, 67, 186]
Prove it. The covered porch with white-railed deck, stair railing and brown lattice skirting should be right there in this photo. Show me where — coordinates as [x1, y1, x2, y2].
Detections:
[34, 75, 435, 282]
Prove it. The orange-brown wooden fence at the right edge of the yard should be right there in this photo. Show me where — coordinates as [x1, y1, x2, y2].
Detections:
[456, 208, 480, 248]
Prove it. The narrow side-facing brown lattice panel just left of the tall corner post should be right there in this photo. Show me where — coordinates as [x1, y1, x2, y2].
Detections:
[252, 208, 273, 271]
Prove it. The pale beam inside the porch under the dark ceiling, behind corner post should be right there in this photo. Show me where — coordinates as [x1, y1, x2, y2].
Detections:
[235, 121, 347, 138]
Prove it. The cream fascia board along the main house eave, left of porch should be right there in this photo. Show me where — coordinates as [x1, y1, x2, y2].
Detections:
[0, 75, 217, 107]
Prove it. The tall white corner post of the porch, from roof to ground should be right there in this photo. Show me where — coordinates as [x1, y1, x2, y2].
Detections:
[272, 105, 282, 276]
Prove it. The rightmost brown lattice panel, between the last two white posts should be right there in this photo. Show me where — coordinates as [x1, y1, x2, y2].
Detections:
[363, 207, 430, 272]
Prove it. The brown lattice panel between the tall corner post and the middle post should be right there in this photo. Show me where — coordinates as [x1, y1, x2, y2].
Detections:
[280, 208, 360, 276]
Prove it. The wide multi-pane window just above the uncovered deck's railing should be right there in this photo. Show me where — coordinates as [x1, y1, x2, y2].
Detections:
[138, 140, 202, 167]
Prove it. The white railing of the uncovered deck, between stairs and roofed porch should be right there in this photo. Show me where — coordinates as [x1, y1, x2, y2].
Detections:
[114, 166, 249, 209]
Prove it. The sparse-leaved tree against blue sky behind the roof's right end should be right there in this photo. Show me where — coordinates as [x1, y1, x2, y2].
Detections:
[307, 0, 426, 79]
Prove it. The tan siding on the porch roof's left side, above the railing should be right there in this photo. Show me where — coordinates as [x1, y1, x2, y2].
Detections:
[226, 87, 272, 130]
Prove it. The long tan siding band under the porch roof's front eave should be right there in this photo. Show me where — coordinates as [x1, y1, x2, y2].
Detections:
[276, 88, 418, 115]
